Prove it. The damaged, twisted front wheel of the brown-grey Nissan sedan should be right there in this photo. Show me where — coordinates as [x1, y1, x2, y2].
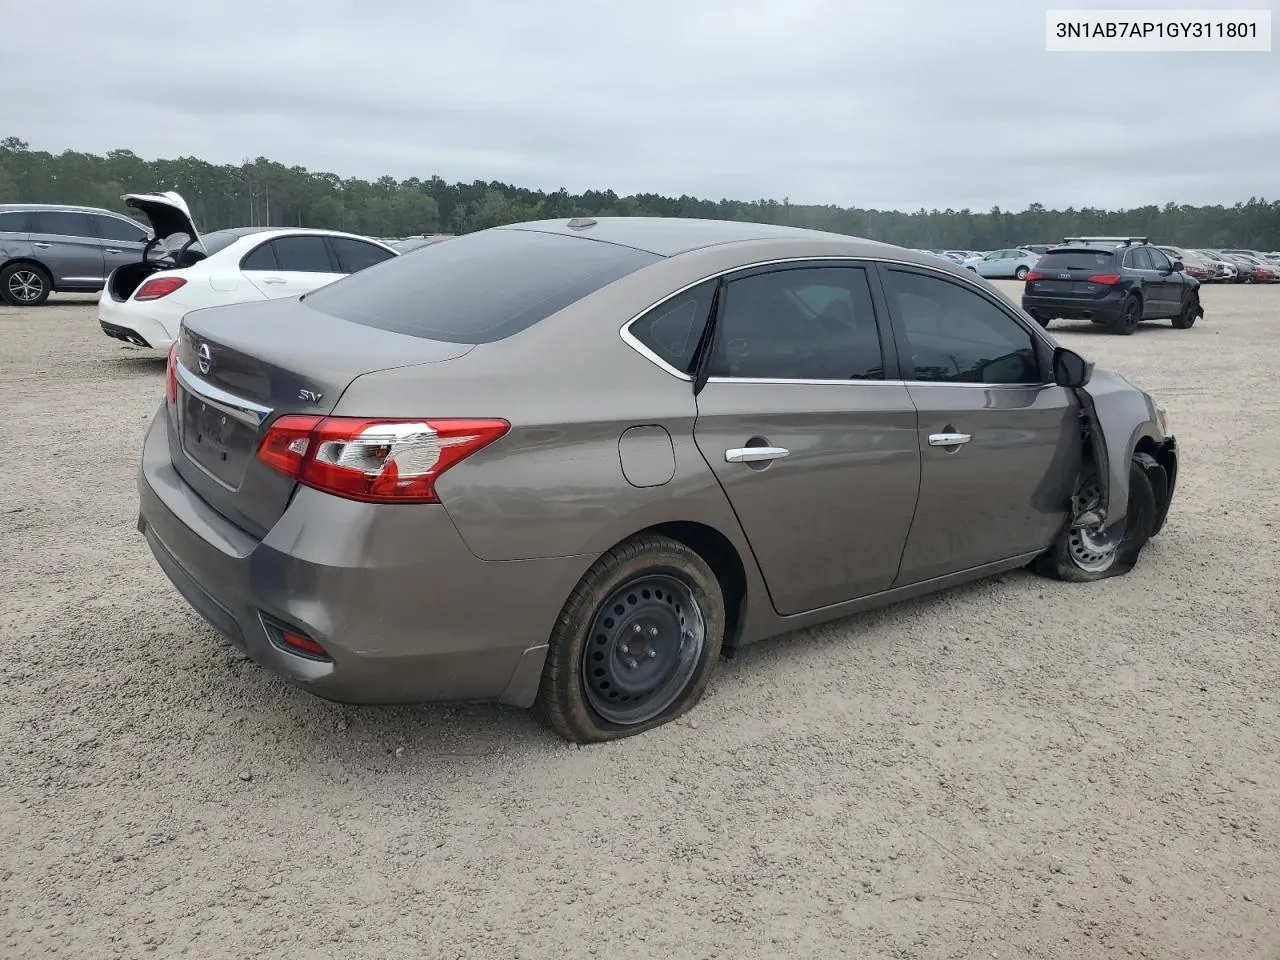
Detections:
[1034, 462, 1156, 582]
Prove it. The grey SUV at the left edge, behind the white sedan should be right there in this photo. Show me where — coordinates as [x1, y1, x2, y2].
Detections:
[0, 204, 151, 307]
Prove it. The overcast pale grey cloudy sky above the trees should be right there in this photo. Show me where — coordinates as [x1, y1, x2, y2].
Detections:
[10, 0, 1280, 210]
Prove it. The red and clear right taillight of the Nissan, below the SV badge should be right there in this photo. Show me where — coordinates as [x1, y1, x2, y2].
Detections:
[257, 415, 511, 503]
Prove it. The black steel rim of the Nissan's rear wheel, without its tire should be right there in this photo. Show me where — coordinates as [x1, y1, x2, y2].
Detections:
[582, 575, 707, 727]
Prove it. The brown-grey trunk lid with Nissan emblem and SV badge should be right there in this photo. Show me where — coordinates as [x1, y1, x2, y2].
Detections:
[169, 298, 474, 536]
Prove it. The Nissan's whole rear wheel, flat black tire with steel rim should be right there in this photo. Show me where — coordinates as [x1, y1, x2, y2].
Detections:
[534, 534, 724, 744]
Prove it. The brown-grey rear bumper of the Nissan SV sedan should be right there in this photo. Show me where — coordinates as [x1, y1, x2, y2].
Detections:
[138, 408, 594, 707]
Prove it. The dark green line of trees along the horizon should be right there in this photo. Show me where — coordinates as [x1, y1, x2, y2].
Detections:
[0, 137, 1280, 251]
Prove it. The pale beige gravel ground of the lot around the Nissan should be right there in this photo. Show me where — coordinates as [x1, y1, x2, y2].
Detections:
[0, 284, 1280, 960]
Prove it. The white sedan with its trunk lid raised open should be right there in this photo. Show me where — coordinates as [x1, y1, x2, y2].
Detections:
[97, 192, 398, 351]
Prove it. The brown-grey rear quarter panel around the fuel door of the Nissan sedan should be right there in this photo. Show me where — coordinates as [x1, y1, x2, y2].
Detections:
[334, 244, 803, 566]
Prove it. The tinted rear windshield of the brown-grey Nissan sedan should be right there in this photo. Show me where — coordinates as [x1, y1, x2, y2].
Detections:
[305, 229, 662, 343]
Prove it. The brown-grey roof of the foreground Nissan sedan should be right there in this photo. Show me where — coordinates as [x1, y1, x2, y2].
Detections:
[497, 216, 901, 262]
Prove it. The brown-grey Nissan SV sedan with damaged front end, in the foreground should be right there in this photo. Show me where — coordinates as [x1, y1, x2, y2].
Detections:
[138, 218, 1178, 742]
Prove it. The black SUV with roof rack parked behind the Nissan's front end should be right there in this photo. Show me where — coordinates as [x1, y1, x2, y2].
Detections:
[1023, 237, 1204, 334]
